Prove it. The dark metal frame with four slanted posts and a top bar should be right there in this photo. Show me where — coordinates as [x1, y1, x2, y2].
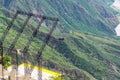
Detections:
[0, 11, 59, 80]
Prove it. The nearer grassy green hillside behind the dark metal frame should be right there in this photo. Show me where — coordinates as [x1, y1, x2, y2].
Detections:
[0, 7, 120, 80]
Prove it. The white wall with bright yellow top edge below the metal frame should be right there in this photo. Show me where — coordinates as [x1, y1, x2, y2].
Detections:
[7, 63, 62, 80]
